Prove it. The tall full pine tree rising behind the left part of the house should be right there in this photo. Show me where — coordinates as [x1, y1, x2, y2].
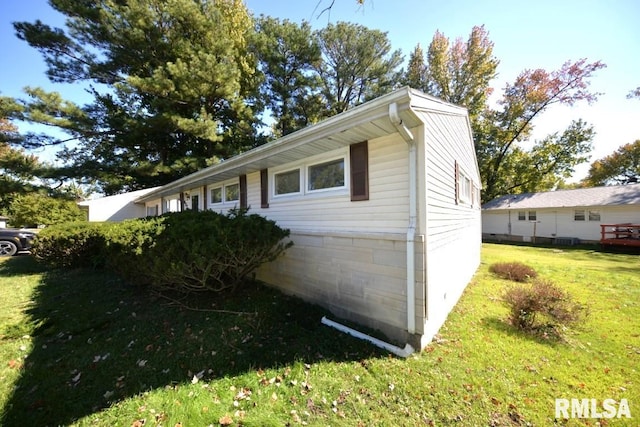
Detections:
[15, 0, 259, 194]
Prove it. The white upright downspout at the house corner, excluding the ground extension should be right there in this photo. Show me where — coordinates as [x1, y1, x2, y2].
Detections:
[389, 102, 418, 334]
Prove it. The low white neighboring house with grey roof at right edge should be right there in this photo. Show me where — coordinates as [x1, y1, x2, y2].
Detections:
[482, 184, 640, 244]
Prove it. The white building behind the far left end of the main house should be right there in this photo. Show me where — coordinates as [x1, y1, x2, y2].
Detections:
[78, 187, 158, 221]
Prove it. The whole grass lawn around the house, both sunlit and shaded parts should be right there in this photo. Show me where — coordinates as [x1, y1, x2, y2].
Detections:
[0, 244, 640, 427]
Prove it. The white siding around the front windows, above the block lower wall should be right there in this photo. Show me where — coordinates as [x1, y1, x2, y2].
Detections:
[252, 135, 409, 233]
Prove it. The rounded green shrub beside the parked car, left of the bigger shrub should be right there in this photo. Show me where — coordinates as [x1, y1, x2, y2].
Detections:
[31, 222, 107, 268]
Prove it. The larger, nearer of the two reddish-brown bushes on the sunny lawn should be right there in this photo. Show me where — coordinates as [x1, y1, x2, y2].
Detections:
[503, 279, 586, 336]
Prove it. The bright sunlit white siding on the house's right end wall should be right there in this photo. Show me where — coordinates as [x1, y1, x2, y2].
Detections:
[416, 111, 482, 342]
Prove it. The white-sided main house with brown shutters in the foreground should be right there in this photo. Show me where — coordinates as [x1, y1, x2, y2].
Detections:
[137, 88, 481, 348]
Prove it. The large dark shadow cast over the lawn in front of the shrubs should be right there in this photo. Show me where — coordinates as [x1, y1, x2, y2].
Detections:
[0, 257, 386, 426]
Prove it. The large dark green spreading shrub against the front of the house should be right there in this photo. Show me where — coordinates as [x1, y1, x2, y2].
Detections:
[107, 210, 292, 292]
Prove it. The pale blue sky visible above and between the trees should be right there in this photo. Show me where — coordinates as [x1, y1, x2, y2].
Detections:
[0, 0, 640, 179]
